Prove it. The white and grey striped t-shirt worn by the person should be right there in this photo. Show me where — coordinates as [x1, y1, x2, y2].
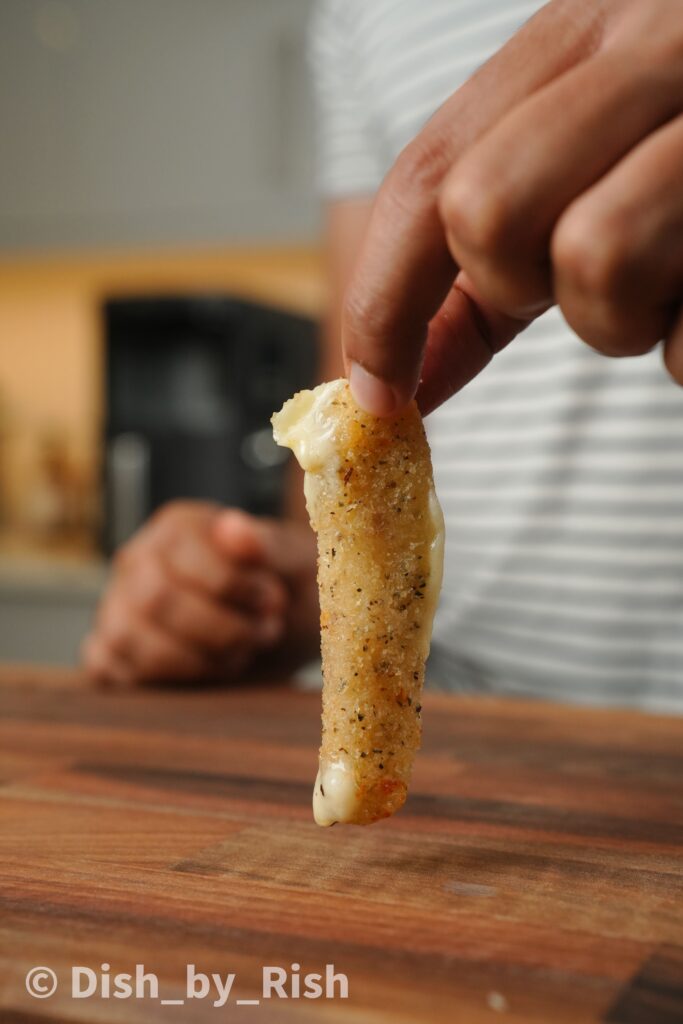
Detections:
[311, 0, 683, 712]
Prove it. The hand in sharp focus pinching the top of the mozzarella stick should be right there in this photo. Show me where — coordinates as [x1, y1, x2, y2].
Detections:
[343, 0, 683, 415]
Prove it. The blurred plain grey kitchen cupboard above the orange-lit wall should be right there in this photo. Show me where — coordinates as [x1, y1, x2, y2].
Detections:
[0, 0, 318, 255]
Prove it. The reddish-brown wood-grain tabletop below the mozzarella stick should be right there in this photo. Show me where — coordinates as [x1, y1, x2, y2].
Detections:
[0, 671, 683, 1024]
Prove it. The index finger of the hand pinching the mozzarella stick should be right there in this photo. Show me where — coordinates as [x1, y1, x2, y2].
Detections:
[342, 0, 599, 416]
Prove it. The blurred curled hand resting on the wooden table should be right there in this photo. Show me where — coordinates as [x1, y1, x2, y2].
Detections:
[82, 502, 317, 685]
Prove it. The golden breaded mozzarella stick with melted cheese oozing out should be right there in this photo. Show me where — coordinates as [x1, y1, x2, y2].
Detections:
[272, 380, 443, 825]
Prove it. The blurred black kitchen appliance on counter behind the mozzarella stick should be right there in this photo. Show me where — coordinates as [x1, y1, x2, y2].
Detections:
[102, 295, 317, 553]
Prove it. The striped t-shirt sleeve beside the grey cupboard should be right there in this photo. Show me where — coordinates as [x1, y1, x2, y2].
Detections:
[308, 0, 384, 200]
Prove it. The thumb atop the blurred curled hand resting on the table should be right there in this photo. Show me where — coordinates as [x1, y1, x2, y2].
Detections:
[213, 509, 315, 579]
